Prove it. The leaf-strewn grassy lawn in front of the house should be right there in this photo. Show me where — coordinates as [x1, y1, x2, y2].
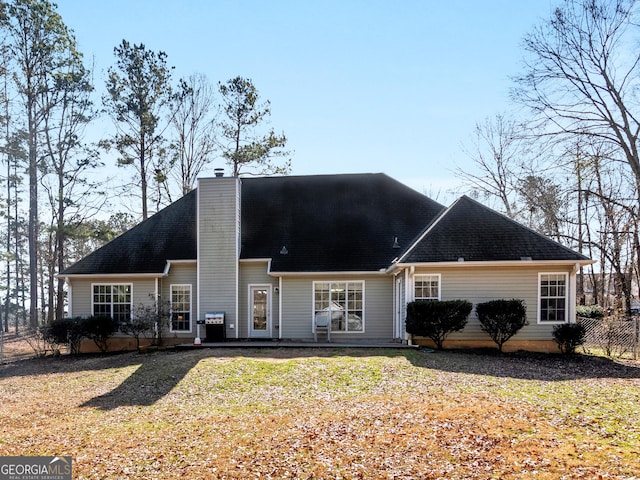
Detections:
[0, 349, 640, 479]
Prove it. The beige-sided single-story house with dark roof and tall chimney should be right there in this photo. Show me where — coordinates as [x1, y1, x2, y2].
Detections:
[61, 174, 592, 350]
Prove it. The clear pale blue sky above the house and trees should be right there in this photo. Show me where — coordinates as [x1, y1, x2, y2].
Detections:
[57, 0, 556, 204]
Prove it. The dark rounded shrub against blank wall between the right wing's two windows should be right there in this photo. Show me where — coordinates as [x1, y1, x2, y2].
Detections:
[476, 299, 527, 352]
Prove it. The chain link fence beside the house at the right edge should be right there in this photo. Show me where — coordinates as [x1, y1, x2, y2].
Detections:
[577, 316, 640, 360]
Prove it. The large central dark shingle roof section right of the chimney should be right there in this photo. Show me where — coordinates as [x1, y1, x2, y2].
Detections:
[241, 173, 445, 272]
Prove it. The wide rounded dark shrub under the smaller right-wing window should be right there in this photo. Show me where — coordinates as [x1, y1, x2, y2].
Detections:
[406, 300, 473, 350]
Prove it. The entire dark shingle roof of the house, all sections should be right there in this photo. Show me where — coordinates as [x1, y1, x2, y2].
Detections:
[62, 174, 587, 275]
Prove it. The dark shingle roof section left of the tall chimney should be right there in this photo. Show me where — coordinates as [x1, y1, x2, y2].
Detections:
[61, 190, 197, 276]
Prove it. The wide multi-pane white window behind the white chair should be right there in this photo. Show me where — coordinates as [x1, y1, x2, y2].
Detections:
[313, 282, 364, 332]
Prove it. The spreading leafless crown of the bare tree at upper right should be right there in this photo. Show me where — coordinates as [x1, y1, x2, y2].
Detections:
[514, 0, 640, 193]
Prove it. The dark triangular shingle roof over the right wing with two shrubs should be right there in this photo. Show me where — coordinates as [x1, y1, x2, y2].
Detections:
[399, 196, 589, 263]
